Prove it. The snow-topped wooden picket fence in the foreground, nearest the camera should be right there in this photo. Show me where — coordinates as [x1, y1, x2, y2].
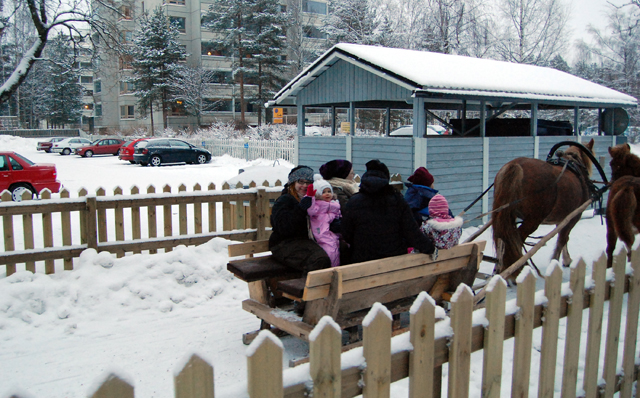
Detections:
[71, 251, 640, 398]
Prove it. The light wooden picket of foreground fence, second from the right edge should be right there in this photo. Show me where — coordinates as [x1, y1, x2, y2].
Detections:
[603, 247, 627, 397]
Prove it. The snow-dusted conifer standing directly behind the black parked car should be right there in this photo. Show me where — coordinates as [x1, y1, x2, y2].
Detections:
[129, 7, 187, 135]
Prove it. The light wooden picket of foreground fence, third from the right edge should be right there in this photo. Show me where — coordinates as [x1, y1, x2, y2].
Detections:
[583, 253, 607, 398]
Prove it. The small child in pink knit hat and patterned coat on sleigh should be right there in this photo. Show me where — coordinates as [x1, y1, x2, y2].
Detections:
[420, 194, 462, 249]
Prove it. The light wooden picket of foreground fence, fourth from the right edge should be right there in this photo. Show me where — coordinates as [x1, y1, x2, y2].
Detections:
[561, 259, 587, 398]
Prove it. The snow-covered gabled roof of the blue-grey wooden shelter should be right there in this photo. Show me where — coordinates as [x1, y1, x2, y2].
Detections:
[275, 43, 637, 106]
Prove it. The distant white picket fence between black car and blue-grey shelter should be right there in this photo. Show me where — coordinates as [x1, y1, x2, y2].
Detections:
[188, 138, 296, 162]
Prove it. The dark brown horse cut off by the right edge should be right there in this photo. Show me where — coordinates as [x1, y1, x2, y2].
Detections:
[606, 144, 640, 267]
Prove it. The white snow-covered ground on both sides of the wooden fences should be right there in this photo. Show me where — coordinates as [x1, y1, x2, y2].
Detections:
[0, 137, 636, 398]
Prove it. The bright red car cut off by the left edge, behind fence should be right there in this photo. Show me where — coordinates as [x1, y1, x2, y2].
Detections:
[0, 152, 60, 202]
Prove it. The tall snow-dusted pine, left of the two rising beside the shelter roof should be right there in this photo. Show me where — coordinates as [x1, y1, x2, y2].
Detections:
[205, 0, 256, 129]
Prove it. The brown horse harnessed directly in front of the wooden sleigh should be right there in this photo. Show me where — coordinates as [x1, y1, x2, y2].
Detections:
[492, 139, 594, 280]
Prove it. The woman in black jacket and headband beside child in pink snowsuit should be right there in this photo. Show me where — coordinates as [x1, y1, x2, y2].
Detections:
[269, 166, 331, 273]
